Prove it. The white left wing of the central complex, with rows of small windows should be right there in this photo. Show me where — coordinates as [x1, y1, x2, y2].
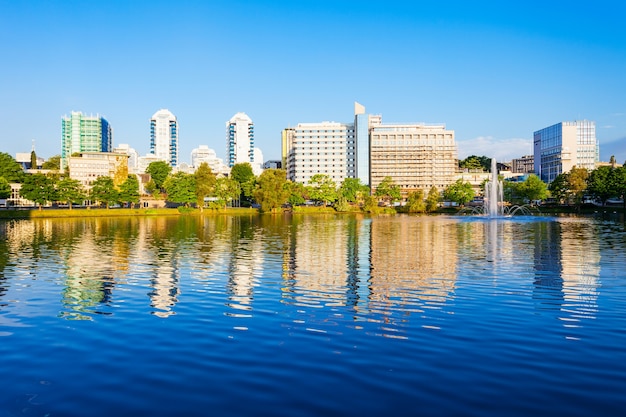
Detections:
[282, 122, 355, 184]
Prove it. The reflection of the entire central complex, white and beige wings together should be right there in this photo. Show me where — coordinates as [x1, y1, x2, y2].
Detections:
[284, 216, 457, 337]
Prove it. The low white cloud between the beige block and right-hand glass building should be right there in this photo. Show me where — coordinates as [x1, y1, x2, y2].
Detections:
[456, 136, 533, 162]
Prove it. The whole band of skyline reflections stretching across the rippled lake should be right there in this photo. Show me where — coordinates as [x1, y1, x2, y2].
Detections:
[0, 215, 601, 328]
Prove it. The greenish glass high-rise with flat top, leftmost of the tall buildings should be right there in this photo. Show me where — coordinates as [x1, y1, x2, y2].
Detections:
[61, 111, 113, 169]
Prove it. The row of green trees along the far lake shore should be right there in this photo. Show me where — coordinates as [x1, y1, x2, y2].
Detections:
[0, 153, 626, 213]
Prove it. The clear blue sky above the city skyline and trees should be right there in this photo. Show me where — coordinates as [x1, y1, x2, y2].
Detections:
[0, 0, 626, 162]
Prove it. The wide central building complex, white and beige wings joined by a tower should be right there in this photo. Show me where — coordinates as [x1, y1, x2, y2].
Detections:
[282, 103, 457, 197]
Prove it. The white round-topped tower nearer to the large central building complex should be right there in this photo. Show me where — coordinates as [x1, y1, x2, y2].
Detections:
[226, 112, 255, 167]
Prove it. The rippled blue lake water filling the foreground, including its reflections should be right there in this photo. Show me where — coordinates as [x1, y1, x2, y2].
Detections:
[0, 215, 626, 417]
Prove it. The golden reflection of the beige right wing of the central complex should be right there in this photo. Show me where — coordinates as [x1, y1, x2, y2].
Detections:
[360, 216, 458, 329]
